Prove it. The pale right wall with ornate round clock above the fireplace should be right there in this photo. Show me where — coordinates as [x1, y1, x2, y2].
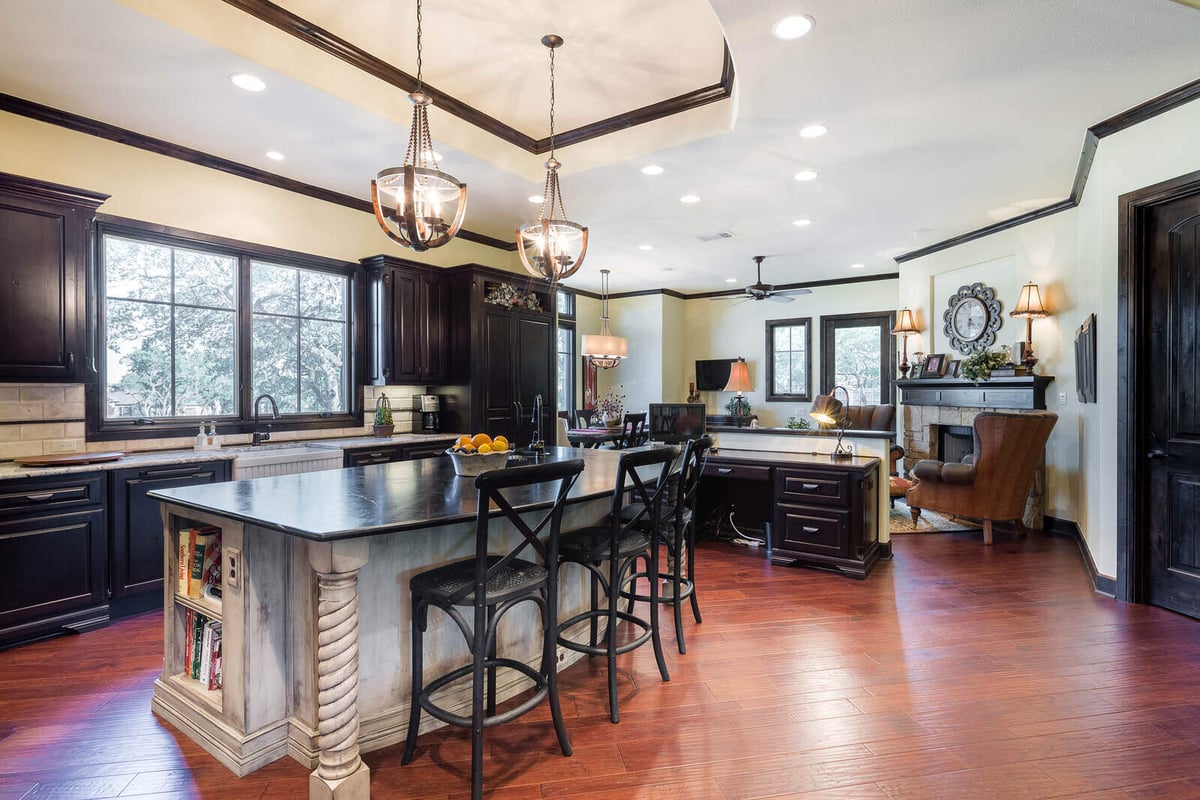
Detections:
[900, 102, 1200, 577]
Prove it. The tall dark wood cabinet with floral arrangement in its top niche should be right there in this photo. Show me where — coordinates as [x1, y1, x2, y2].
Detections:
[433, 266, 557, 447]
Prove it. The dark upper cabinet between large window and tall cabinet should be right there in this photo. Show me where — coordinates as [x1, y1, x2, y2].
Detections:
[362, 255, 449, 385]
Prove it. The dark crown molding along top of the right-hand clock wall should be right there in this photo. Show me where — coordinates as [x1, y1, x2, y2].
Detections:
[895, 79, 1200, 264]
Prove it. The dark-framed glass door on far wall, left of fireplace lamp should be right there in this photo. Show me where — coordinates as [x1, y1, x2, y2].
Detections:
[821, 312, 896, 405]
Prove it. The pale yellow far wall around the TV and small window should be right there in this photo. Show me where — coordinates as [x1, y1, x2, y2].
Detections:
[682, 278, 912, 427]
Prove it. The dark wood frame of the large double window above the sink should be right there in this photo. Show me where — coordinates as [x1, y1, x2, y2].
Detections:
[85, 215, 366, 441]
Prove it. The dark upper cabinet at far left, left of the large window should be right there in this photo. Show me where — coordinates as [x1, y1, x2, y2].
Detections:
[0, 173, 108, 381]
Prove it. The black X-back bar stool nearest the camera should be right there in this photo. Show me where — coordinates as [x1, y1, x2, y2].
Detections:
[401, 458, 583, 800]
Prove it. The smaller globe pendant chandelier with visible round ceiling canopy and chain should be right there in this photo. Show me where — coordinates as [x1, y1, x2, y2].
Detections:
[517, 34, 588, 283]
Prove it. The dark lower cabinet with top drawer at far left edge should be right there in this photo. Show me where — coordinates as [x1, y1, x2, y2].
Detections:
[0, 473, 108, 645]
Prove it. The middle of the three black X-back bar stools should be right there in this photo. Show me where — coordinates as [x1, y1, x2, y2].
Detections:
[558, 447, 676, 722]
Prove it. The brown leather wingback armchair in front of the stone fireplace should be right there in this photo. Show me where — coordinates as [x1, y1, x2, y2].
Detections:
[905, 411, 1058, 545]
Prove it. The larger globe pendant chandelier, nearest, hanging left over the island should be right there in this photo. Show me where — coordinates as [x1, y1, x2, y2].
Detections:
[371, 0, 467, 252]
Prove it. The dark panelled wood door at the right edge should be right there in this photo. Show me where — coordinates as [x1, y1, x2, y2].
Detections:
[1140, 187, 1200, 618]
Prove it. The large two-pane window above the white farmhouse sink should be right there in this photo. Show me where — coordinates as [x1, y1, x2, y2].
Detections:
[89, 224, 355, 438]
